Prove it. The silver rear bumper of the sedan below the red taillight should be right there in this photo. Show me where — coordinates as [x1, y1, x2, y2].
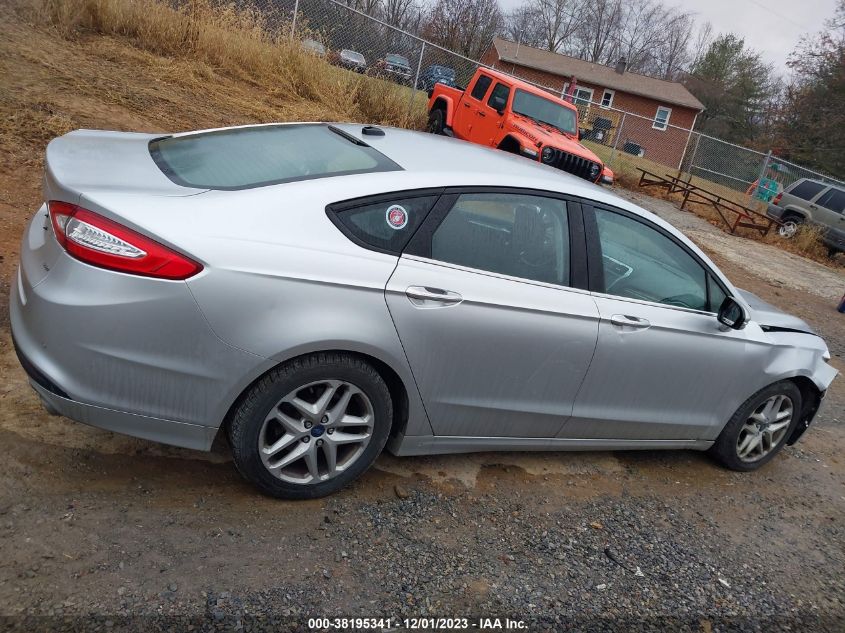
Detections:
[9, 207, 272, 449]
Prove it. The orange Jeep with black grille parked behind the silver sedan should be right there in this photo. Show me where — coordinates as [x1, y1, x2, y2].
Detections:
[427, 68, 613, 184]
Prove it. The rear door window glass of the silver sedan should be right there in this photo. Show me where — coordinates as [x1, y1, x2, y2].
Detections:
[431, 193, 570, 286]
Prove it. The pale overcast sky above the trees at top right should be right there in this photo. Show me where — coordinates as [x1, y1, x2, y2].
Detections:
[499, 0, 836, 74]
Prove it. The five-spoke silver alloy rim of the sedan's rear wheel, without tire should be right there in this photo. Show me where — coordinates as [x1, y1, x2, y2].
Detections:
[258, 380, 375, 484]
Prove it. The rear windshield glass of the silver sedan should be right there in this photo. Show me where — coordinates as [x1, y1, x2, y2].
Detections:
[150, 124, 401, 189]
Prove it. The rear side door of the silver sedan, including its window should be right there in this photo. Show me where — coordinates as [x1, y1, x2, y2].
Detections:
[386, 189, 598, 438]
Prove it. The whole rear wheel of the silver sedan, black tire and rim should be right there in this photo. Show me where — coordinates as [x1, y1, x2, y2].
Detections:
[229, 353, 393, 499]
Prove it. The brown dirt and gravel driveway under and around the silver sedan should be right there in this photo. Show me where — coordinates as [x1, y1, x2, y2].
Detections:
[0, 189, 845, 632]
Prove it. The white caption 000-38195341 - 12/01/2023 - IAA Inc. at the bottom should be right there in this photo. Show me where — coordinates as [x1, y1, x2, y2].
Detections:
[308, 617, 528, 631]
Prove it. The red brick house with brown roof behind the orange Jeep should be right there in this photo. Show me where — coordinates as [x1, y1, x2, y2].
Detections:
[481, 38, 704, 168]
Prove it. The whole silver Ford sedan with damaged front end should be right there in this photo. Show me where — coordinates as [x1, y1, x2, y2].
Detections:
[11, 123, 836, 498]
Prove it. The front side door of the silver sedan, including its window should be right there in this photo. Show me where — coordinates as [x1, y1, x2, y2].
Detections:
[561, 205, 768, 440]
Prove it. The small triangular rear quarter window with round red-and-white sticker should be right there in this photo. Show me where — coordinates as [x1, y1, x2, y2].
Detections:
[327, 193, 440, 255]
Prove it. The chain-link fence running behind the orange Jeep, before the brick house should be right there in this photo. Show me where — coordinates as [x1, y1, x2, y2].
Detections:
[252, 0, 845, 204]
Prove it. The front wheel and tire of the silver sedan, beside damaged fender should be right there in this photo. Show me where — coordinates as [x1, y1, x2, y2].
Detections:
[710, 380, 802, 471]
